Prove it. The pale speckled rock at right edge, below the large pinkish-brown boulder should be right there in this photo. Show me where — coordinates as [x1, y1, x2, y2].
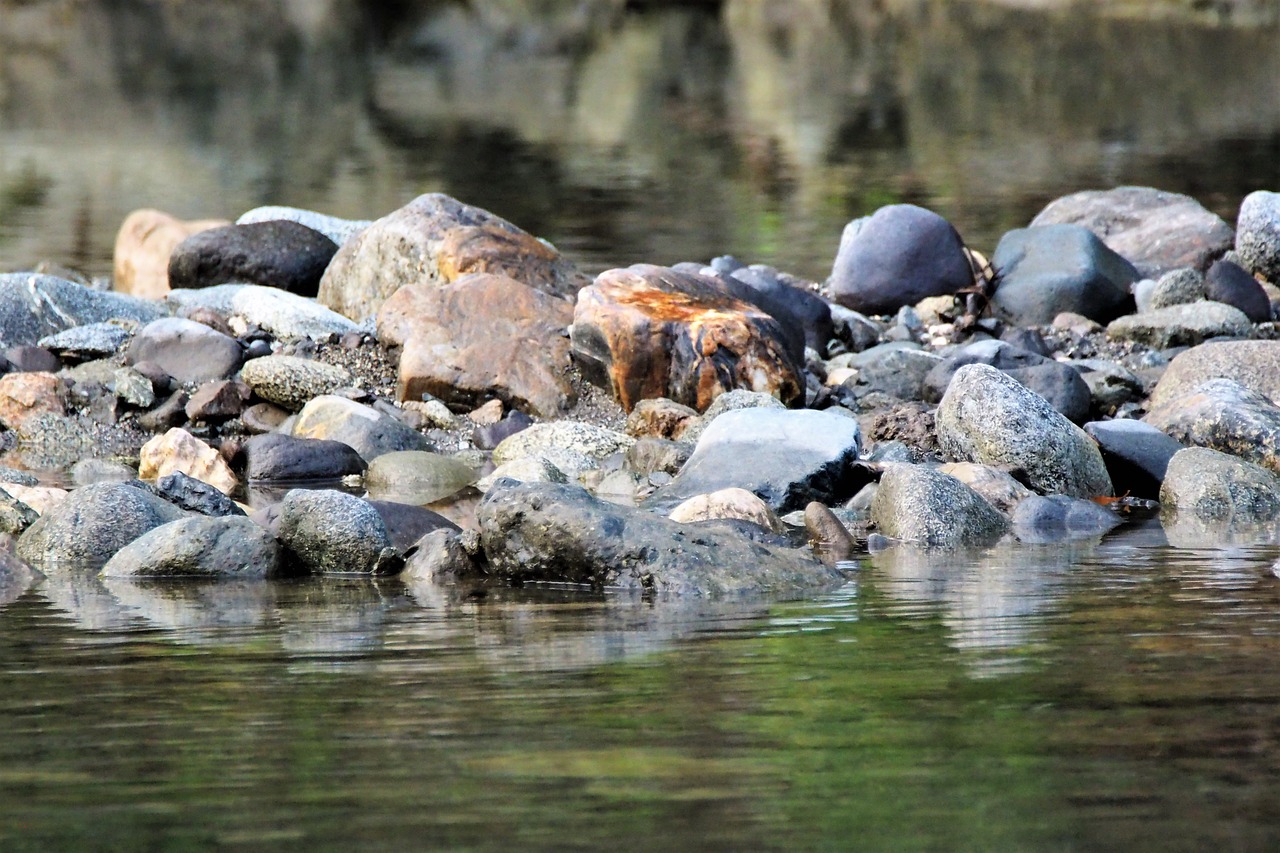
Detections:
[1143, 379, 1280, 471]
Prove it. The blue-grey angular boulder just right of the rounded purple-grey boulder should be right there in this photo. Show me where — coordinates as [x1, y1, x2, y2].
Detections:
[991, 225, 1139, 325]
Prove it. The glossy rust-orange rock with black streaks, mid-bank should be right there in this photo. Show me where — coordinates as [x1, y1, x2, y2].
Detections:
[572, 264, 804, 412]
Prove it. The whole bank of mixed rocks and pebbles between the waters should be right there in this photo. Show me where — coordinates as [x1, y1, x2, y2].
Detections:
[0, 187, 1280, 597]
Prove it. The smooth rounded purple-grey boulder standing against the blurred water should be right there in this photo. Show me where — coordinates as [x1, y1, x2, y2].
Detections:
[829, 205, 974, 314]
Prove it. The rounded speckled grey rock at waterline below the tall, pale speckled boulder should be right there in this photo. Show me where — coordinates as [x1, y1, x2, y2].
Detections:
[872, 466, 1009, 548]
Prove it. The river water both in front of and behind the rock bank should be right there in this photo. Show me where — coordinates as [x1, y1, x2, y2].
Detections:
[0, 0, 1280, 852]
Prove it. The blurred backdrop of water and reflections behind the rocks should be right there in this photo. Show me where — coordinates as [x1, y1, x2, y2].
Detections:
[0, 0, 1280, 279]
